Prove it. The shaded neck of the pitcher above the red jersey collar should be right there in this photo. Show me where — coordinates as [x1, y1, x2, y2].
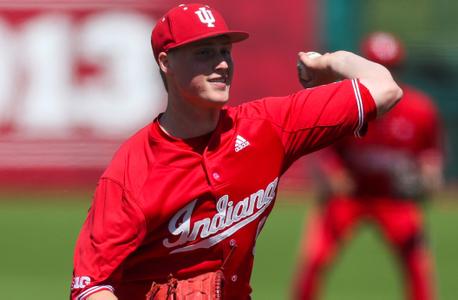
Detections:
[159, 102, 220, 139]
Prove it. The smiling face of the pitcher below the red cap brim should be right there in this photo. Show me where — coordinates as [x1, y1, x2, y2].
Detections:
[168, 37, 233, 107]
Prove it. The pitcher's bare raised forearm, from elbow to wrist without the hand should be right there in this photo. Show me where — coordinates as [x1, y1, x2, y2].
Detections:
[325, 51, 402, 116]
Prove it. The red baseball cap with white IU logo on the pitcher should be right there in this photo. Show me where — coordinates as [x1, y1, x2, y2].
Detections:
[151, 3, 248, 61]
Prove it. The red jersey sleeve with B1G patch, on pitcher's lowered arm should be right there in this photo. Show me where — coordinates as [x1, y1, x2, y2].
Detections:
[70, 178, 146, 300]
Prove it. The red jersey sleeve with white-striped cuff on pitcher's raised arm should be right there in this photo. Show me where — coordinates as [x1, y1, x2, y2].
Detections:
[242, 79, 376, 165]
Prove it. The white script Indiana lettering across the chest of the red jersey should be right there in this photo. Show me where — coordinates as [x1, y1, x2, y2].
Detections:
[163, 177, 278, 253]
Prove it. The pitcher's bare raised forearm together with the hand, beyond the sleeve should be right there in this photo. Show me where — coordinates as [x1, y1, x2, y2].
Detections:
[298, 51, 402, 116]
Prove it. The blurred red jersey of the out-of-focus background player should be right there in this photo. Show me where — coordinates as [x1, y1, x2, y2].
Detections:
[325, 86, 443, 198]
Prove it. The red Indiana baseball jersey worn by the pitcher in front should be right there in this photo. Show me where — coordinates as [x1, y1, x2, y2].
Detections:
[71, 80, 376, 300]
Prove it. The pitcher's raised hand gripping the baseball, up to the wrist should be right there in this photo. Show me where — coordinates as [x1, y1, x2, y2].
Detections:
[297, 52, 341, 88]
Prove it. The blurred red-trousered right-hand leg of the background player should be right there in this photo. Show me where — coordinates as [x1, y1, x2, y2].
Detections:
[378, 201, 435, 300]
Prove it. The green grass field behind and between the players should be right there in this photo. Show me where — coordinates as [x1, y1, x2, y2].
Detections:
[0, 191, 458, 300]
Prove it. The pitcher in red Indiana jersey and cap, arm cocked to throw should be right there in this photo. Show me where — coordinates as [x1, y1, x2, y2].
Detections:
[71, 4, 402, 300]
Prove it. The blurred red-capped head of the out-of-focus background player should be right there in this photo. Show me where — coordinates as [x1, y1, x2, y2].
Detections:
[361, 31, 405, 68]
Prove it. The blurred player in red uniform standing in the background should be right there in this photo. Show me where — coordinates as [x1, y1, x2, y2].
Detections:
[295, 32, 443, 300]
